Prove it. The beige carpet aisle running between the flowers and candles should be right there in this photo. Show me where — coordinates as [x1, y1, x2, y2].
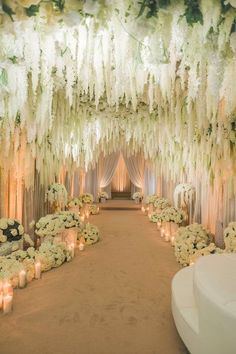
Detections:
[0, 201, 187, 354]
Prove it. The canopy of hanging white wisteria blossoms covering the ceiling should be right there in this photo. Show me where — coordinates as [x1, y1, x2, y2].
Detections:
[0, 0, 236, 189]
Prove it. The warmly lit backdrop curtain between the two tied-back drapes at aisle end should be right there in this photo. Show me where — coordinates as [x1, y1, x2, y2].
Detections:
[111, 154, 131, 192]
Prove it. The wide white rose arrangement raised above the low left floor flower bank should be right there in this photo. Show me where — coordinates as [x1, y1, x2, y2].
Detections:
[35, 211, 80, 238]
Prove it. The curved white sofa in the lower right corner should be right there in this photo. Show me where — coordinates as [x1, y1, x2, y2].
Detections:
[172, 254, 236, 354]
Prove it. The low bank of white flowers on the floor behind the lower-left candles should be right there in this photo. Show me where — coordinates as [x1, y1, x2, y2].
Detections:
[0, 242, 72, 287]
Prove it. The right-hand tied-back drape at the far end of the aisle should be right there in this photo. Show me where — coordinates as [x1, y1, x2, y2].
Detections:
[123, 154, 145, 190]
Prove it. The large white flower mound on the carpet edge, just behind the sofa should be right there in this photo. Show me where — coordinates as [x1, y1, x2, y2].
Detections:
[175, 223, 213, 266]
